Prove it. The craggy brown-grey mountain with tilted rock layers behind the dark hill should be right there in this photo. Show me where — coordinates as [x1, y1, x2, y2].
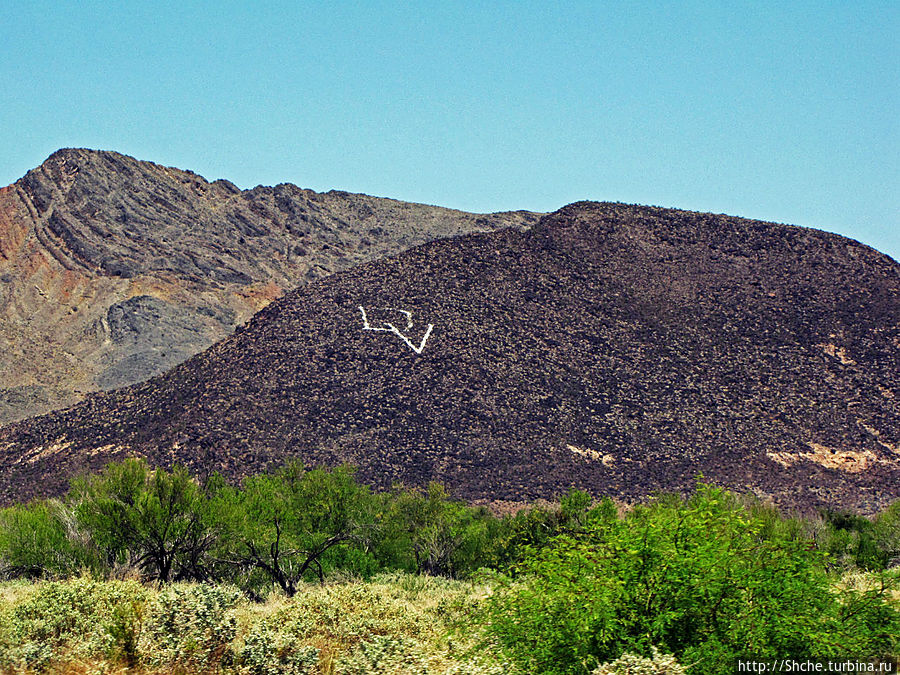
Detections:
[0, 150, 538, 423]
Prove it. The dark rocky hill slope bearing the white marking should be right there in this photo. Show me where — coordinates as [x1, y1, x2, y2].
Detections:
[0, 203, 900, 511]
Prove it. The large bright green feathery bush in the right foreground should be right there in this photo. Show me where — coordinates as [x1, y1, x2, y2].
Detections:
[488, 485, 900, 673]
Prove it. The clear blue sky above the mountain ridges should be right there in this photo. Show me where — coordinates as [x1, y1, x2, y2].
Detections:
[0, 0, 900, 258]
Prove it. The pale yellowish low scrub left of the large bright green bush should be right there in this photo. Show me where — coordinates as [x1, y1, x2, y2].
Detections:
[0, 573, 511, 675]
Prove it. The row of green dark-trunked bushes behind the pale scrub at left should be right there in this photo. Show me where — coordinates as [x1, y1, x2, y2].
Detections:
[0, 459, 540, 599]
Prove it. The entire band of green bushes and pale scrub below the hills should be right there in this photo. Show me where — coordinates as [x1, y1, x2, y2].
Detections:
[0, 460, 900, 674]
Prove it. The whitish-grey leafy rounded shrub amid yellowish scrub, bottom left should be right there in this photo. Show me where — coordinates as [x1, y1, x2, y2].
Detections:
[139, 584, 241, 670]
